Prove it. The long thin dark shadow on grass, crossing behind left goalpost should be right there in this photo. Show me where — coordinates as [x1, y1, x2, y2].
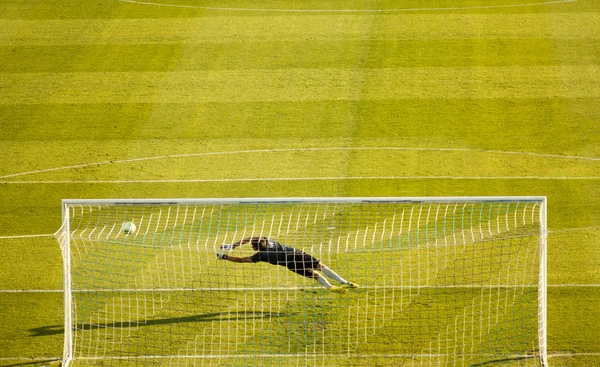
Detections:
[29, 311, 290, 336]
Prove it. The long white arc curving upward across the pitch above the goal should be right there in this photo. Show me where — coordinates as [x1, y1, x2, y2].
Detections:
[0, 147, 600, 183]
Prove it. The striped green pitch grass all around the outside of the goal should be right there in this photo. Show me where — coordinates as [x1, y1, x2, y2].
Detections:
[0, 0, 600, 366]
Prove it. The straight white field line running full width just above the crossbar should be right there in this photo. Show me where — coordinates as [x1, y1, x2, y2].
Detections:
[0, 176, 600, 185]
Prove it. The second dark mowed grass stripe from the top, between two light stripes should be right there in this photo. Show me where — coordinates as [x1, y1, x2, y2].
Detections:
[0, 39, 600, 73]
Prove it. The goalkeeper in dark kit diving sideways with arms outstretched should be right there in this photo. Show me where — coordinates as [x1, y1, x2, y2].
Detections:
[217, 237, 358, 294]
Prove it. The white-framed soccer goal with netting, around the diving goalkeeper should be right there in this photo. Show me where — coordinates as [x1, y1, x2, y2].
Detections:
[56, 197, 547, 367]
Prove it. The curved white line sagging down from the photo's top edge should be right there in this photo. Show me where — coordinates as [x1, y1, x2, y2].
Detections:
[118, 0, 578, 13]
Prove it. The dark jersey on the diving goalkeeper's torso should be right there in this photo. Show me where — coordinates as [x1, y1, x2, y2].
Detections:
[250, 239, 320, 276]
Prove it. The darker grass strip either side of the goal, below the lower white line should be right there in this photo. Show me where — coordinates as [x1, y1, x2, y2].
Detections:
[0, 288, 600, 366]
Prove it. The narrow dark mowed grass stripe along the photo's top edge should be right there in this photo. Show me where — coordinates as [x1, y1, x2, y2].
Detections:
[0, 0, 598, 19]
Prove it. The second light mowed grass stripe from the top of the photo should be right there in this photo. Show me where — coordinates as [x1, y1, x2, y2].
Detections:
[0, 66, 600, 104]
